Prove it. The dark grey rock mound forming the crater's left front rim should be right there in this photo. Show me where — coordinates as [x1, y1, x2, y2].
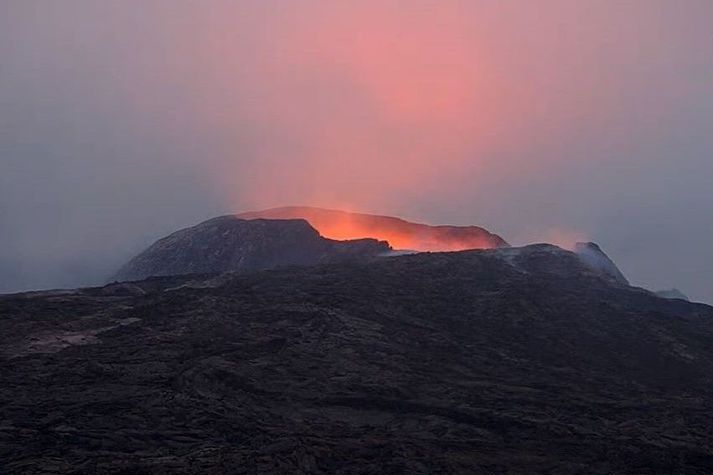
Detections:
[114, 216, 390, 281]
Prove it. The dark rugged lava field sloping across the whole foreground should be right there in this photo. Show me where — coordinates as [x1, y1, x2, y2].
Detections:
[0, 245, 713, 474]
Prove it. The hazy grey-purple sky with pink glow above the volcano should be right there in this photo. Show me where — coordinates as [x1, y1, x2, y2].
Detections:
[0, 0, 713, 302]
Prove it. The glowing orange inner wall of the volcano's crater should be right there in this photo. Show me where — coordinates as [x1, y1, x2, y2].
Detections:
[237, 206, 509, 252]
